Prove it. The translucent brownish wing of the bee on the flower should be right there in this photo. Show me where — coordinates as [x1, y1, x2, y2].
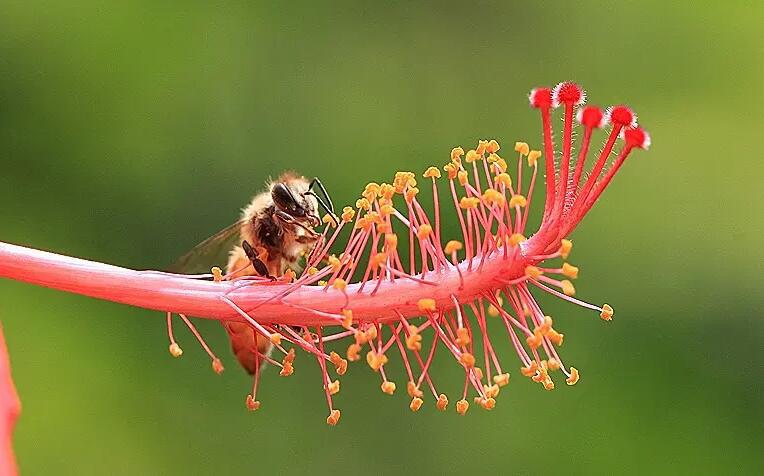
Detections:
[168, 220, 242, 274]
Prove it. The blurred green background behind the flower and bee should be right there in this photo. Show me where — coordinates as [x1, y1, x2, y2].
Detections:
[0, 0, 764, 474]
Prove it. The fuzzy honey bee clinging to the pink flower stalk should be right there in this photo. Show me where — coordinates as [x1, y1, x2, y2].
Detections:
[172, 172, 337, 374]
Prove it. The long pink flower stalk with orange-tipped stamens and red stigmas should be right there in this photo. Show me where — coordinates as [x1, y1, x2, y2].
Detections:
[0, 82, 650, 425]
